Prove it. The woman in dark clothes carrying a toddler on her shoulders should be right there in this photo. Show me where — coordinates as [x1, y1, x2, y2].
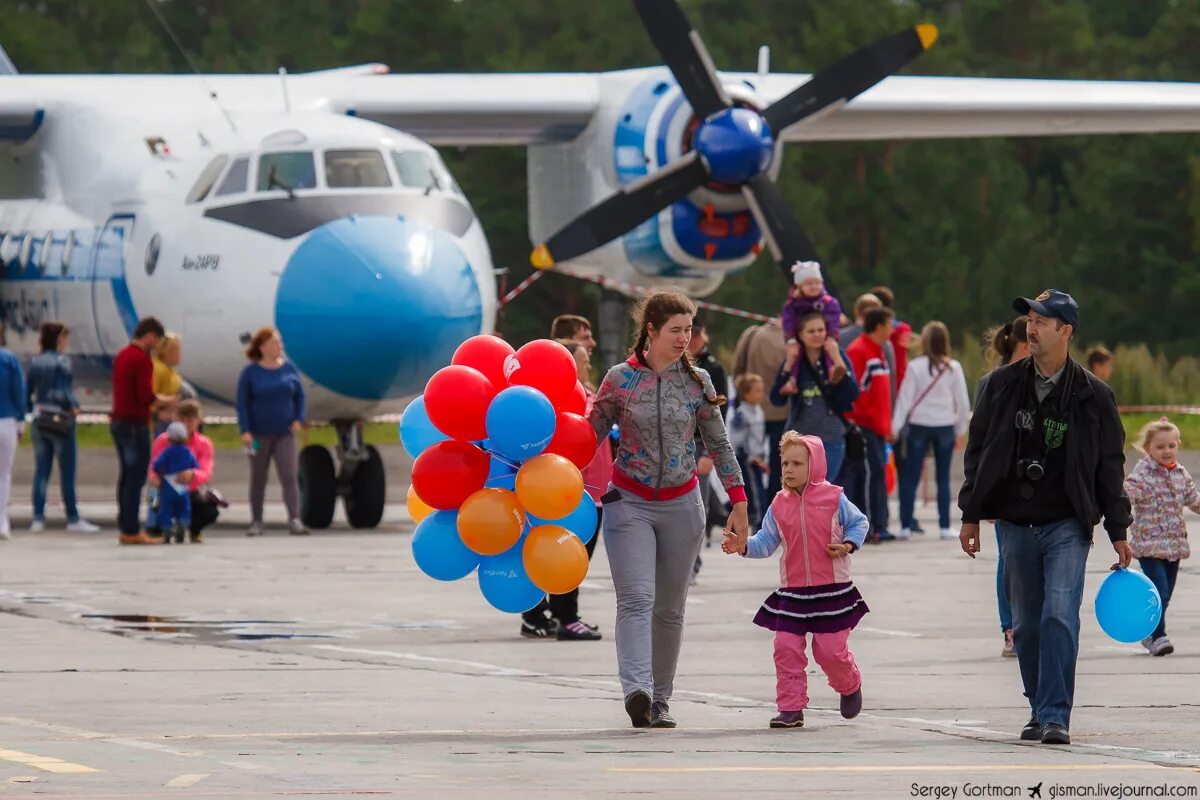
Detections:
[770, 312, 858, 486]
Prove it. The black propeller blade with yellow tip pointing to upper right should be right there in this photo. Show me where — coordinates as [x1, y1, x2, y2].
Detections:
[762, 24, 937, 137]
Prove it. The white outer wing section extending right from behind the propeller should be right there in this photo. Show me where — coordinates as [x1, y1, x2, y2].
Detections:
[753, 74, 1200, 142]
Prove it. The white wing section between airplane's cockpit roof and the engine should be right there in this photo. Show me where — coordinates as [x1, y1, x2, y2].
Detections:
[330, 73, 600, 145]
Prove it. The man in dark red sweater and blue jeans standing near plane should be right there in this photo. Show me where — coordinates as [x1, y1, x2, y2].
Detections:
[109, 317, 166, 545]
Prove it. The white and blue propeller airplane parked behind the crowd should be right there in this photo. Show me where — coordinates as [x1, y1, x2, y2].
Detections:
[0, 0, 1200, 528]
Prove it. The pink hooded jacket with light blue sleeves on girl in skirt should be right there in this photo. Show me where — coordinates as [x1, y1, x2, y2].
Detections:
[745, 437, 868, 588]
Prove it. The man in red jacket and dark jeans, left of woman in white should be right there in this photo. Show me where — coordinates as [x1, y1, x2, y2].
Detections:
[844, 307, 894, 542]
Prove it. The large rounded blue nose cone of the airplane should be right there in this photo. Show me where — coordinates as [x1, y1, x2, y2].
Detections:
[275, 217, 482, 401]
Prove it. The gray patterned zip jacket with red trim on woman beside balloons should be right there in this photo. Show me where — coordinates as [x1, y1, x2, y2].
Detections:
[588, 356, 746, 503]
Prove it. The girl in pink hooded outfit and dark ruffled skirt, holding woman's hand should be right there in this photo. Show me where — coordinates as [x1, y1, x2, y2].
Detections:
[721, 431, 870, 728]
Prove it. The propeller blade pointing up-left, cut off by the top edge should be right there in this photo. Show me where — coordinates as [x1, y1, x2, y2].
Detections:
[634, 0, 732, 120]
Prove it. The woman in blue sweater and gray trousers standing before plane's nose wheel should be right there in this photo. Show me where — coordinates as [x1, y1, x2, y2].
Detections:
[238, 327, 308, 536]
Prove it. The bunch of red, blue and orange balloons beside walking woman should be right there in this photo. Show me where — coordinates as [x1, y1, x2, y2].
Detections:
[400, 336, 596, 613]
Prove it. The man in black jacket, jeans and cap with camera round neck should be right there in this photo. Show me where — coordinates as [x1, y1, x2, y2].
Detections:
[959, 290, 1133, 745]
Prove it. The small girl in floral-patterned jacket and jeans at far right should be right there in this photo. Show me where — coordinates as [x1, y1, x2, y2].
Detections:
[1126, 416, 1200, 656]
